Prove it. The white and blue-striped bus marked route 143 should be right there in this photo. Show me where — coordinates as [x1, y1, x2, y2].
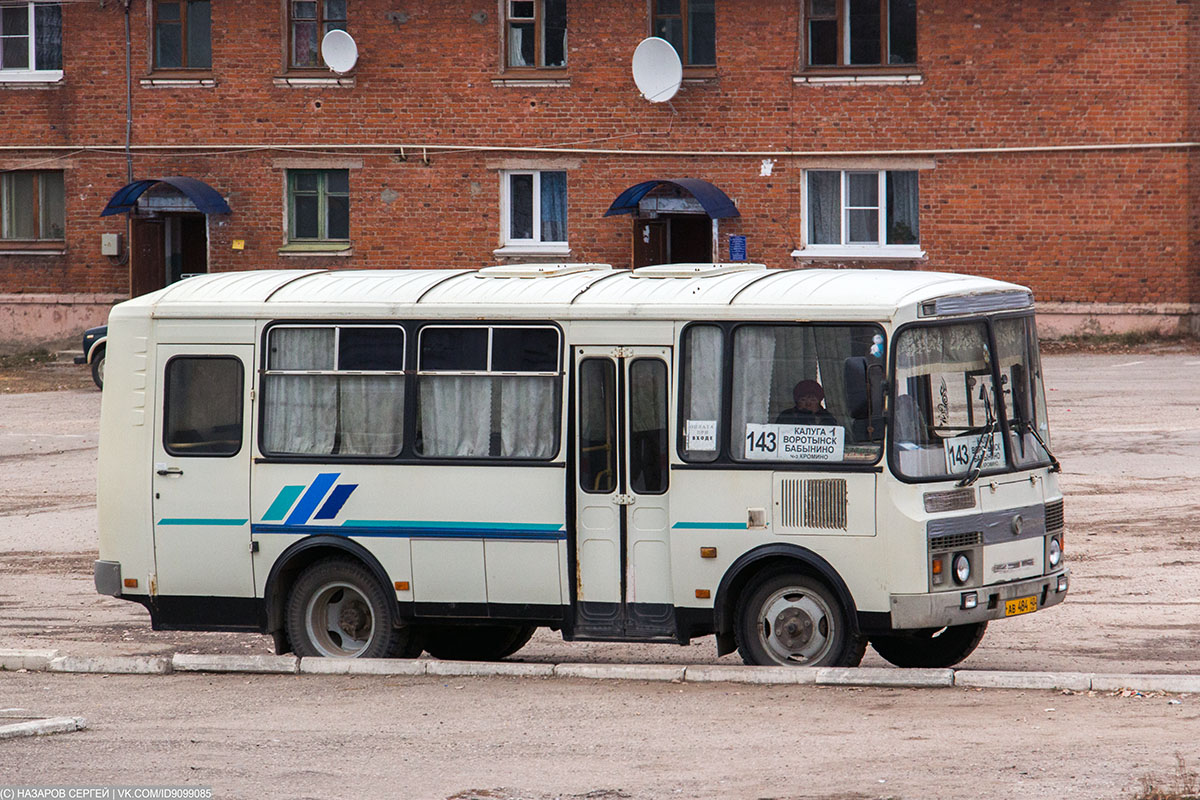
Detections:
[95, 264, 1068, 666]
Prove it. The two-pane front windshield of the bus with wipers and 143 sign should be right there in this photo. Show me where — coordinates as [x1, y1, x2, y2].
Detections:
[892, 317, 1050, 480]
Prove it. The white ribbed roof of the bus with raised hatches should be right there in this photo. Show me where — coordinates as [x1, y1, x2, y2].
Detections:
[110, 264, 1033, 320]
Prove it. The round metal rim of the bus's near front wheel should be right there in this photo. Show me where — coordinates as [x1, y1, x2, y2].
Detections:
[758, 587, 836, 664]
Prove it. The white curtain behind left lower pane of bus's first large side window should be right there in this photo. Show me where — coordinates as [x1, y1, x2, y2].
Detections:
[263, 375, 337, 455]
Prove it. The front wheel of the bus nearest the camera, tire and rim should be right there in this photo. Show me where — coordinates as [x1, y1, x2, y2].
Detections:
[734, 571, 866, 667]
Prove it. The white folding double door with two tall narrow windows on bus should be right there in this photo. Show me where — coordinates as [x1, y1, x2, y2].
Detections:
[574, 347, 676, 639]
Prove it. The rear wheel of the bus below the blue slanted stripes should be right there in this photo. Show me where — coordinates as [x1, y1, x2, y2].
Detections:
[286, 559, 419, 658]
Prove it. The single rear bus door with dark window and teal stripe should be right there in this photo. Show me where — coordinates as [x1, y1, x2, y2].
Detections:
[152, 344, 254, 597]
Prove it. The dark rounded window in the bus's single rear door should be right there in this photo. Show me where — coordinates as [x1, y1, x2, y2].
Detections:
[162, 356, 242, 456]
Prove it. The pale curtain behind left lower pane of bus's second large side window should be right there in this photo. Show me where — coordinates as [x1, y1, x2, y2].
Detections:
[419, 375, 492, 458]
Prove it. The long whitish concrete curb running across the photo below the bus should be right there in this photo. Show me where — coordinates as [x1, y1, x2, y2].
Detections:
[14, 649, 1200, 695]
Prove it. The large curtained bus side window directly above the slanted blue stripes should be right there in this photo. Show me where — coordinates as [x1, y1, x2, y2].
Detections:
[262, 325, 404, 457]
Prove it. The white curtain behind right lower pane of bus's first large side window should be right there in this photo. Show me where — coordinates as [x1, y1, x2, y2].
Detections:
[337, 375, 404, 456]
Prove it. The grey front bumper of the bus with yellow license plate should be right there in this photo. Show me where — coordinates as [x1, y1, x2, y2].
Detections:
[892, 569, 1070, 630]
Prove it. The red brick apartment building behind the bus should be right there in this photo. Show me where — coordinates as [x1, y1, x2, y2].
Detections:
[0, 0, 1200, 345]
